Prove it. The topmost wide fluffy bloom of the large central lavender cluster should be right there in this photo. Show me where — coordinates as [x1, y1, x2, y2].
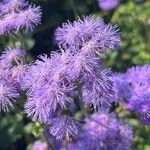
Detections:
[55, 16, 120, 54]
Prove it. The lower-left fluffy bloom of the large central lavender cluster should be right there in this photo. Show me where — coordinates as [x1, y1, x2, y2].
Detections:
[25, 84, 72, 122]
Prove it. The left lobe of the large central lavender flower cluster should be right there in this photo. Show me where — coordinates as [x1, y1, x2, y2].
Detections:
[22, 53, 74, 122]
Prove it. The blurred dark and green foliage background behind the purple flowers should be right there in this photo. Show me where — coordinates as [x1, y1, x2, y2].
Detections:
[0, 0, 150, 150]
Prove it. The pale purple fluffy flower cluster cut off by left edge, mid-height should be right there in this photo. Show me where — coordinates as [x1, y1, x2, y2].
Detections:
[0, 48, 27, 112]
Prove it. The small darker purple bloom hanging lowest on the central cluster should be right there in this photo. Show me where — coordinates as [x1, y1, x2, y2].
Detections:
[50, 116, 82, 141]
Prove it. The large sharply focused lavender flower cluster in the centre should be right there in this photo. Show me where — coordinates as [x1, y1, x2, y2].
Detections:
[22, 16, 120, 140]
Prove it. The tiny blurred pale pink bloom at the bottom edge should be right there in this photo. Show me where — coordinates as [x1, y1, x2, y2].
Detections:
[32, 141, 48, 150]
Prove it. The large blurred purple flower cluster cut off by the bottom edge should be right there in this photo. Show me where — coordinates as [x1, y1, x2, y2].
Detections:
[67, 112, 133, 150]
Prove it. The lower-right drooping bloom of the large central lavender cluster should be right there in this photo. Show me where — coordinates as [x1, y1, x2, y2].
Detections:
[82, 66, 114, 109]
